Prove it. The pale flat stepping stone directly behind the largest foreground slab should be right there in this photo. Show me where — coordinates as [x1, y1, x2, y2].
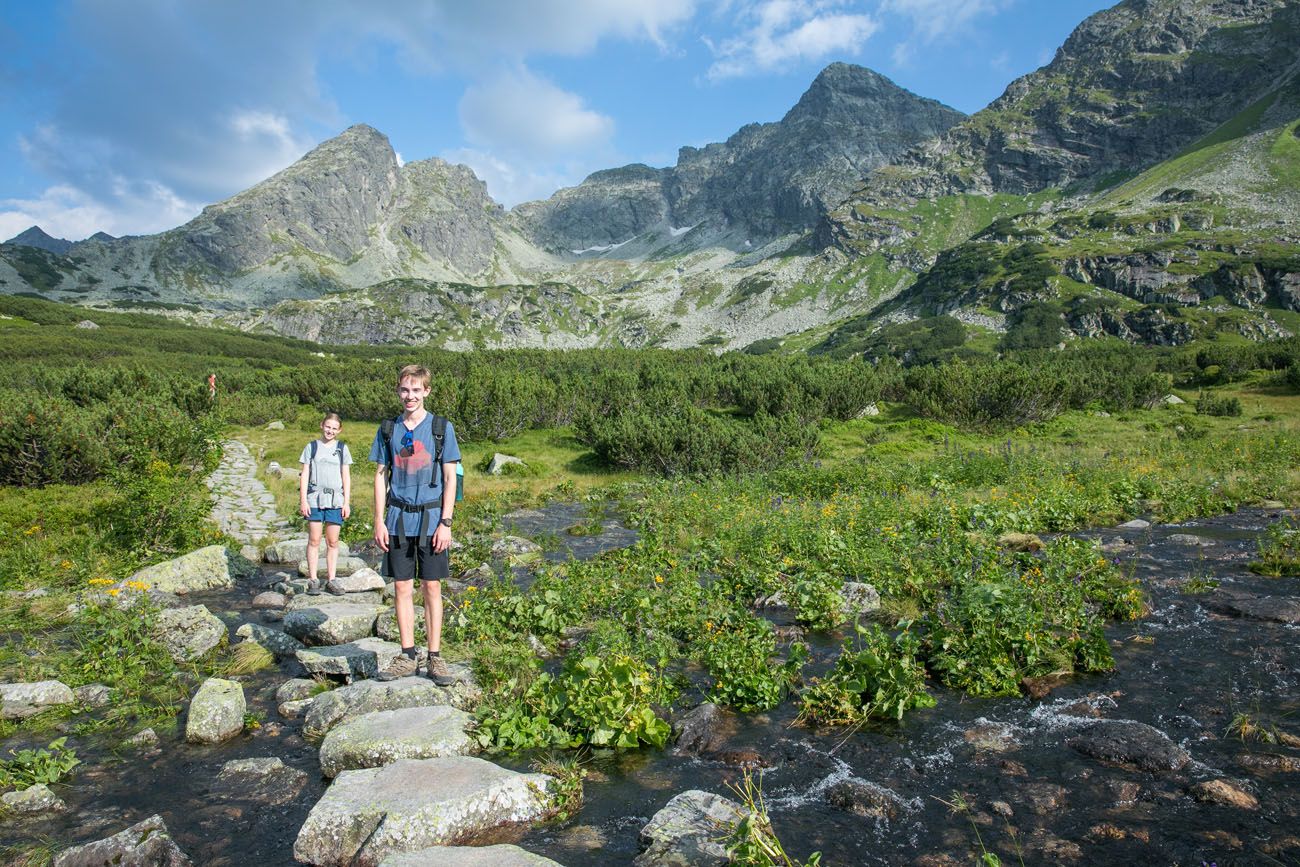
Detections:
[320, 705, 477, 777]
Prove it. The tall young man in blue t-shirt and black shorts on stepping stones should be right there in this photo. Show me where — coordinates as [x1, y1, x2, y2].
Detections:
[371, 364, 460, 686]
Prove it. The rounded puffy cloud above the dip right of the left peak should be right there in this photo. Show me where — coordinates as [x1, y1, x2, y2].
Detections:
[460, 68, 614, 157]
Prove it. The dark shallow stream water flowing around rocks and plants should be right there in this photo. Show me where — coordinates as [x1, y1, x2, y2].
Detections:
[0, 506, 1300, 867]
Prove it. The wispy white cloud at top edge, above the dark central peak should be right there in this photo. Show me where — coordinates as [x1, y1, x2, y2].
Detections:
[707, 0, 879, 81]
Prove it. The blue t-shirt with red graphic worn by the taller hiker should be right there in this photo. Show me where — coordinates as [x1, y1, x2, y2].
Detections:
[371, 412, 460, 537]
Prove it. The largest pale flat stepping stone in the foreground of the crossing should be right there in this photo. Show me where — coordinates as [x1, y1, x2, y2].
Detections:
[294, 755, 554, 867]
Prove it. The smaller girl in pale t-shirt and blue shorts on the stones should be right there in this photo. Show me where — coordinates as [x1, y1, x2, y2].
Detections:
[298, 412, 352, 595]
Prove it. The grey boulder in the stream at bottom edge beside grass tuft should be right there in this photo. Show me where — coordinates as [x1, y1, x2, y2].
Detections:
[632, 789, 745, 867]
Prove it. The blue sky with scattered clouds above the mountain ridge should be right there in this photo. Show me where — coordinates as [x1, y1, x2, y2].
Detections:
[0, 0, 1112, 240]
